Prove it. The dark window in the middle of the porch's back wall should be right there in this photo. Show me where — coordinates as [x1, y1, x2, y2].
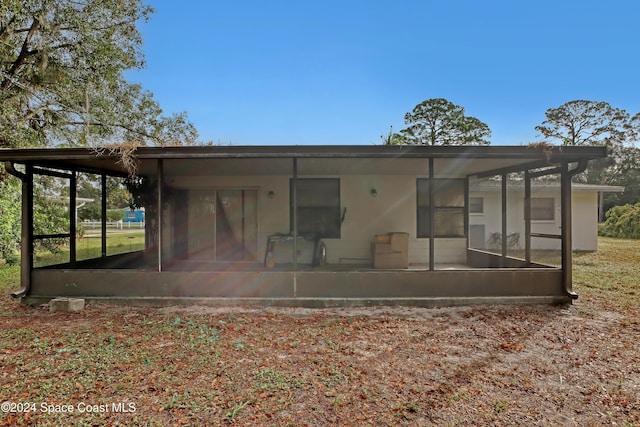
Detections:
[290, 178, 340, 238]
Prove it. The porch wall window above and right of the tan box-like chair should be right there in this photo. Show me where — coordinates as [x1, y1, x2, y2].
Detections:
[417, 179, 465, 237]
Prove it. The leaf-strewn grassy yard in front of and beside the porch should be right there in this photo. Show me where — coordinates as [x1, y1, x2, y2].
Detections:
[0, 238, 640, 426]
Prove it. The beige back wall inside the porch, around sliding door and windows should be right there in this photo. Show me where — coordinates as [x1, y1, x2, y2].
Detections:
[164, 175, 466, 265]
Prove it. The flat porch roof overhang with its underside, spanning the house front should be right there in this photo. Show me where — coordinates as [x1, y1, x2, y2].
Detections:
[0, 145, 607, 177]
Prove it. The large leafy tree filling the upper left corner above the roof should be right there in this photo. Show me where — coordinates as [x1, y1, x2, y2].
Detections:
[0, 0, 197, 148]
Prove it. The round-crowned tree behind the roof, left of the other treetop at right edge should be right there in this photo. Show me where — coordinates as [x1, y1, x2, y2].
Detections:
[400, 98, 491, 145]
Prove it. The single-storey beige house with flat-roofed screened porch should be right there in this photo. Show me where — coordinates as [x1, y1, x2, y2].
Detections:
[0, 146, 606, 306]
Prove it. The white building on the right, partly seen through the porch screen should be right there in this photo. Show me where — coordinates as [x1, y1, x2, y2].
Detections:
[469, 180, 624, 251]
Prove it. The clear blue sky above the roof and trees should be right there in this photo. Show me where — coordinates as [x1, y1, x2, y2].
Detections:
[127, 0, 640, 145]
